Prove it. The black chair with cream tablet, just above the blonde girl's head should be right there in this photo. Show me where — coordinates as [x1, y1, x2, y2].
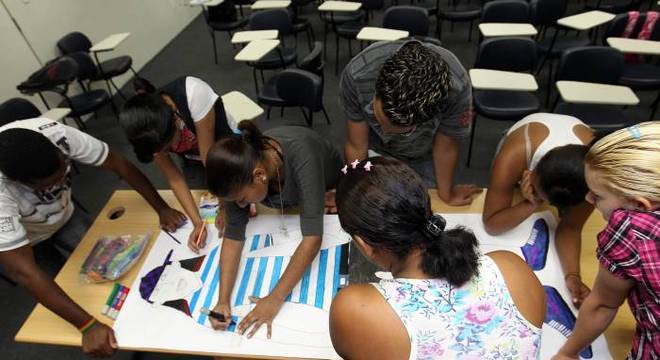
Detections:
[552, 46, 639, 131]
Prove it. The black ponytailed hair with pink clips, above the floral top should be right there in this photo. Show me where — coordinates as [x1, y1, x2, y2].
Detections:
[336, 157, 479, 286]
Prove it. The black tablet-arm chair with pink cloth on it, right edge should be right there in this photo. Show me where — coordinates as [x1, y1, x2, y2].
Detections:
[603, 13, 660, 120]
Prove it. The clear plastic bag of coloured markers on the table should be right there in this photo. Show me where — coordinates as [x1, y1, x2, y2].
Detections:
[80, 233, 151, 283]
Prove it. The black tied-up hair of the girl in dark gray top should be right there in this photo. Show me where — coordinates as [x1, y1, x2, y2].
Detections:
[206, 120, 270, 197]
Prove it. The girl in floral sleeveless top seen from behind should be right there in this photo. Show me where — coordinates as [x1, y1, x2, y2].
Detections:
[330, 157, 545, 359]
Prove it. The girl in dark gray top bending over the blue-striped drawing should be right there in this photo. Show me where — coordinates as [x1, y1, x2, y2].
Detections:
[204, 121, 342, 337]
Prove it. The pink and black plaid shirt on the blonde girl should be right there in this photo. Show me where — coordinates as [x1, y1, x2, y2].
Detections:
[597, 209, 660, 359]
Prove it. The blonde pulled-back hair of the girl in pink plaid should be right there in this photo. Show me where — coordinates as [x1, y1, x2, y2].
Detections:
[584, 121, 660, 201]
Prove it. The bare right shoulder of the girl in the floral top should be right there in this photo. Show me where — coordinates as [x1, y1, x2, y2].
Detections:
[486, 251, 546, 328]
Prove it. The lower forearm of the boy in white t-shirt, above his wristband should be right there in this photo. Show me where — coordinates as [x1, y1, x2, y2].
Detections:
[12, 267, 91, 327]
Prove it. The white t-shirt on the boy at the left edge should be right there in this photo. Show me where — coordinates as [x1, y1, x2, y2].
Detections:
[0, 118, 109, 251]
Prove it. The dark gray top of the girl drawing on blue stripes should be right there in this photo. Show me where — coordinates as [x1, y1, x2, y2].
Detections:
[225, 126, 343, 240]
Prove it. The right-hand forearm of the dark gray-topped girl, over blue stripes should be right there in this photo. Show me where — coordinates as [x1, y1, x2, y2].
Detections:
[270, 235, 321, 301]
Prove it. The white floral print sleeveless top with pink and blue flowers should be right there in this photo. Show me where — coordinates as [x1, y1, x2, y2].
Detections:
[372, 256, 541, 360]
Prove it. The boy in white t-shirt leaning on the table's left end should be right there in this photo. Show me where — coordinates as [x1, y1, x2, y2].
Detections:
[0, 118, 186, 356]
